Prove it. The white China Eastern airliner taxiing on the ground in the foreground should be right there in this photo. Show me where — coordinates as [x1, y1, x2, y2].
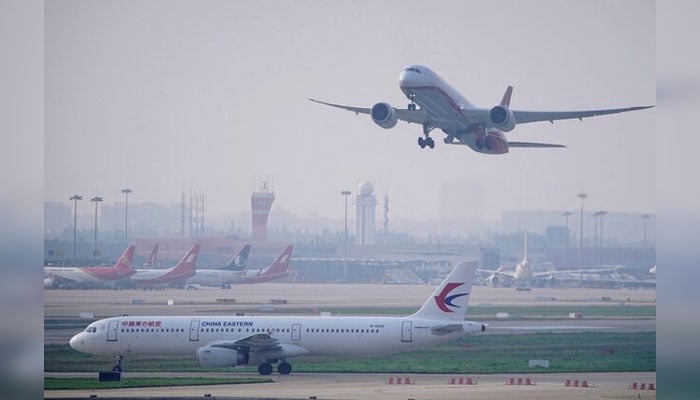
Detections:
[70, 261, 486, 375]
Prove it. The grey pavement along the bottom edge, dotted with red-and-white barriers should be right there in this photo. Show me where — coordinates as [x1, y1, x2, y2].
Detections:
[44, 372, 656, 400]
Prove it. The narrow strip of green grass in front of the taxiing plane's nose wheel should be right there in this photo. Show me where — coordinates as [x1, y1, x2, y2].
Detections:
[44, 378, 272, 390]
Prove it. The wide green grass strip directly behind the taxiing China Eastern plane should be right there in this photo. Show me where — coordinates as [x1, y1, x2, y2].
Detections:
[44, 332, 656, 374]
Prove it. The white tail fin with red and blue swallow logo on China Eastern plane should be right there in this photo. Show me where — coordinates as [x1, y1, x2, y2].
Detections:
[411, 261, 477, 321]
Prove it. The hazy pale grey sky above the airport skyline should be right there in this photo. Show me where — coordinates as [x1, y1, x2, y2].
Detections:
[45, 0, 656, 220]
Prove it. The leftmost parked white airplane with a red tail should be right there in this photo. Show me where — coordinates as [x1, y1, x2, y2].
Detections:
[44, 246, 136, 289]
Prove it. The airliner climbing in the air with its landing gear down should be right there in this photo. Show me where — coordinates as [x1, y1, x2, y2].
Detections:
[309, 65, 653, 154]
